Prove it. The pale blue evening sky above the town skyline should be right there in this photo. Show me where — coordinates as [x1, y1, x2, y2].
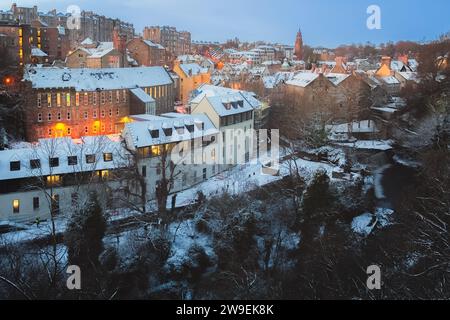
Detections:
[0, 0, 450, 47]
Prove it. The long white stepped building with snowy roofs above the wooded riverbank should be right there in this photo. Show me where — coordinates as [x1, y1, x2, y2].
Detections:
[0, 82, 268, 222]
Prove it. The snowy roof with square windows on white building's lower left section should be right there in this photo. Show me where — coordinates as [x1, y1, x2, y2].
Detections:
[0, 135, 125, 180]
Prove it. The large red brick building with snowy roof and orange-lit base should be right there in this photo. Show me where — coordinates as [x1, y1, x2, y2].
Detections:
[24, 67, 175, 141]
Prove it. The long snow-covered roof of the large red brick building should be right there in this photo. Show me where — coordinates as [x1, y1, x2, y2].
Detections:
[24, 67, 173, 91]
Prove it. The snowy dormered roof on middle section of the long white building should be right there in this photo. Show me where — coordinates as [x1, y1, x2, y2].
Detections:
[122, 114, 218, 148]
